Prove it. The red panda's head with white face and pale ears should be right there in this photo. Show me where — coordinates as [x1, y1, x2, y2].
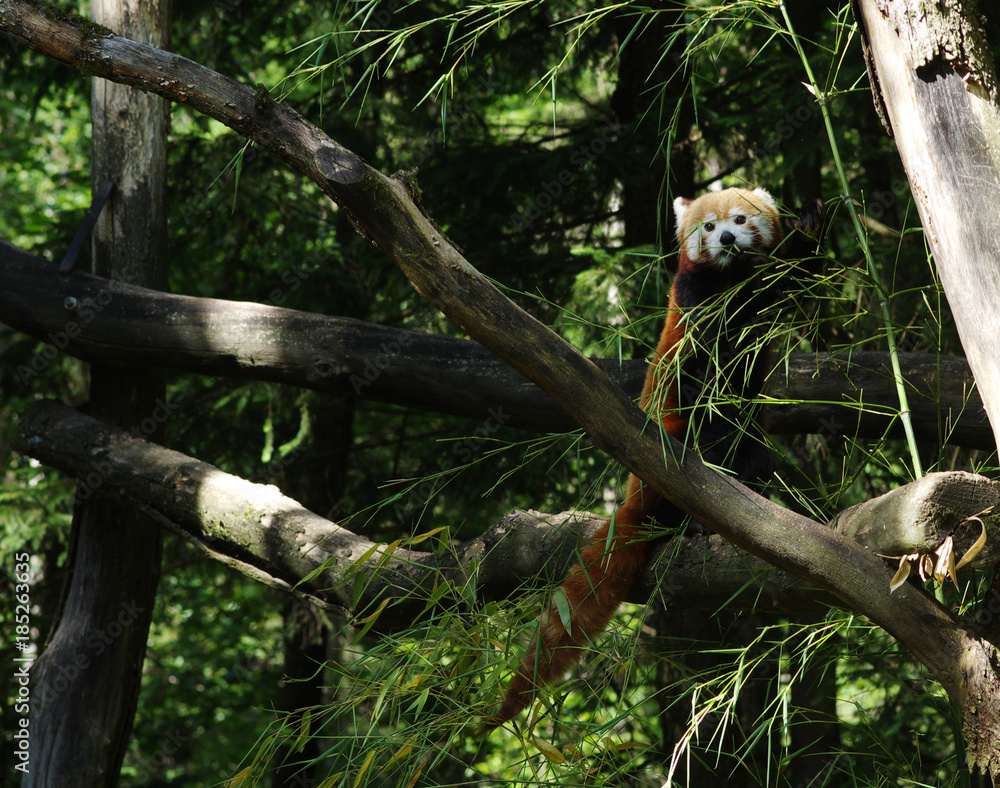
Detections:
[674, 189, 781, 267]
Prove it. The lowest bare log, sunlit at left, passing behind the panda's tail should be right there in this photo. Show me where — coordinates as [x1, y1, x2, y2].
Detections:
[15, 402, 1000, 632]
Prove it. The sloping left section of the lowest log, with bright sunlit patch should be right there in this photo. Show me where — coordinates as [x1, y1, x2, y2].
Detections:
[9, 402, 464, 628]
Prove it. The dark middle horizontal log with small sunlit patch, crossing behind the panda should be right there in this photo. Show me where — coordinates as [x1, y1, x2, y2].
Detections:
[0, 241, 993, 448]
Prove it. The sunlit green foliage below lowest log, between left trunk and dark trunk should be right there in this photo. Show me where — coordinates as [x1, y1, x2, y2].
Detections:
[121, 556, 285, 786]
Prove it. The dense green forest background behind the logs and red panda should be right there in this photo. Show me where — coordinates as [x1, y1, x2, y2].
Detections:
[0, 0, 1000, 786]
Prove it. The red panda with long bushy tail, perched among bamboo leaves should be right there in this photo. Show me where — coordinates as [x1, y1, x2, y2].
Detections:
[487, 189, 822, 728]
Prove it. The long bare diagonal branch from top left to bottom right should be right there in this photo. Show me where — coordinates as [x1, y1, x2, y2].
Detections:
[0, 0, 995, 744]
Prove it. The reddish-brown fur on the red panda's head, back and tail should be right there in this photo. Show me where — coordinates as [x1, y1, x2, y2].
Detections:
[487, 190, 782, 727]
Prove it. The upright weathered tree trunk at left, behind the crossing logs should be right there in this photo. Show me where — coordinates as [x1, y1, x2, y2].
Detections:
[24, 0, 170, 786]
